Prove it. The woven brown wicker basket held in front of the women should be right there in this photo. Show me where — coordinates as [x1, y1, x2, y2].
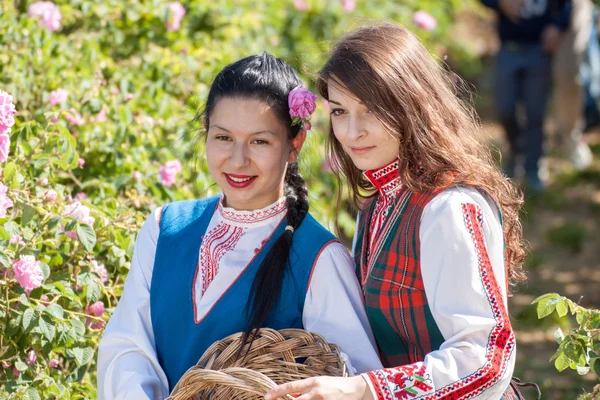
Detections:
[167, 328, 348, 400]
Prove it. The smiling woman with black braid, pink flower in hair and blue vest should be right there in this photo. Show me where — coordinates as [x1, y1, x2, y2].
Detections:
[98, 53, 381, 400]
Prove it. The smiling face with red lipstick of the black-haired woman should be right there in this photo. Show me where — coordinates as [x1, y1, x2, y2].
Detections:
[206, 97, 305, 210]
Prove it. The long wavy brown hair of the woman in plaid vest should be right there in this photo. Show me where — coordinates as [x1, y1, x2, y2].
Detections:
[317, 24, 525, 284]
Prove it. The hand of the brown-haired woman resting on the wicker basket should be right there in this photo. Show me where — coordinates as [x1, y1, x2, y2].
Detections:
[265, 376, 373, 400]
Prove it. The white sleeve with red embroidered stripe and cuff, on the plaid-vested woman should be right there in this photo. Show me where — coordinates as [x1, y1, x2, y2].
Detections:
[363, 188, 516, 400]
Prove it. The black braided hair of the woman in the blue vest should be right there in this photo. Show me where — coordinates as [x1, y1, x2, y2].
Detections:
[199, 52, 308, 353]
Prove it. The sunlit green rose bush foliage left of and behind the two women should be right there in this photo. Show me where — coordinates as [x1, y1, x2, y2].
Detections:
[0, 0, 475, 399]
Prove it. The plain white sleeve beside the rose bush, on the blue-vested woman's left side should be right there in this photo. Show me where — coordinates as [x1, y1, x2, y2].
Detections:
[97, 209, 169, 400]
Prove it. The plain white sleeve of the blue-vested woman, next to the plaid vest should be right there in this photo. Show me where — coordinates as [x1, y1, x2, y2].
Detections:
[302, 242, 382, 373]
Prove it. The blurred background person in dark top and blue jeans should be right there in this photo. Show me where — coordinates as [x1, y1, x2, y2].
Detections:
[481, 0, 572, 191]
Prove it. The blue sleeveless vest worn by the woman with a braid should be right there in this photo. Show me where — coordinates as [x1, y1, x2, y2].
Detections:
[150, 197, 336, 390]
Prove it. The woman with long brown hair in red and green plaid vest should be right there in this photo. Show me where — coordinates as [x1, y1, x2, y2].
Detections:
[266, 24, 524, 400]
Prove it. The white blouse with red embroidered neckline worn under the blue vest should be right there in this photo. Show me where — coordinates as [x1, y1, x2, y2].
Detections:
[98, 198, 381, 400]
